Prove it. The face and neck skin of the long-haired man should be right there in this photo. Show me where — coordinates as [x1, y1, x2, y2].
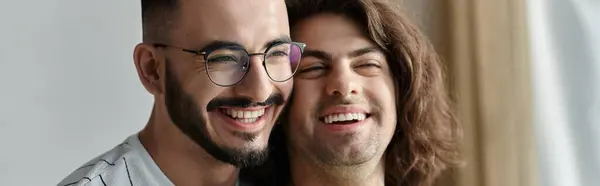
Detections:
[286, 14, 397, 186]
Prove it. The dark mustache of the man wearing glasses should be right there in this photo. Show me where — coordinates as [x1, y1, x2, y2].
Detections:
[206, 93, 285, 112]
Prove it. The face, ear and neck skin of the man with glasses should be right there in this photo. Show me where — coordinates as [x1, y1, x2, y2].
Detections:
[134, 0, 293, 186]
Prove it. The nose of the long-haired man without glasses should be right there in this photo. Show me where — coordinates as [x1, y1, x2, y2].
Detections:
[325, 62, 360, 98]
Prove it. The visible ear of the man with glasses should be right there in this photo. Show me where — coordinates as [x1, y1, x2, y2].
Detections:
[133, 43, 164, 95]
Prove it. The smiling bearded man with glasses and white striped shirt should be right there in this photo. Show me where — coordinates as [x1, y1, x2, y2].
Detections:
[58, 0, 304, 186]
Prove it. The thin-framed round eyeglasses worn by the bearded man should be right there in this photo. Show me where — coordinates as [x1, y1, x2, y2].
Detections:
[154, 41, 306, 87]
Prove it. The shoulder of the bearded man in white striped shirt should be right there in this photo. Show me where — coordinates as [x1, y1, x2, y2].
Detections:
[58, 136, 137, 186]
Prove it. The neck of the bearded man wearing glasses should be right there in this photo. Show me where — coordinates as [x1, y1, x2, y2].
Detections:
[139, 107, 239, 186]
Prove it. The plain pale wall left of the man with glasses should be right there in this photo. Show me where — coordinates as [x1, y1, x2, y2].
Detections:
[0, 0, 152, 186]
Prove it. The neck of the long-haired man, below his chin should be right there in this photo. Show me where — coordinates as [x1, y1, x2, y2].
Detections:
[290, 153, 385, 186]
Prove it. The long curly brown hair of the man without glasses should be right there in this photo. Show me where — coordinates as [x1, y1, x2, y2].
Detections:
[241, 0, 461, 186]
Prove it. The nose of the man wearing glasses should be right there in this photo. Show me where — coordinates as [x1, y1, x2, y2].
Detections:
[234, 56, 274, 102]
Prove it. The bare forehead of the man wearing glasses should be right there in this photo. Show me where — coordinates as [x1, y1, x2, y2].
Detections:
[172, 0, 289, 49]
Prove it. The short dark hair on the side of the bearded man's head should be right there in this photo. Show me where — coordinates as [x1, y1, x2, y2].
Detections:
[142, 0, 179, 42]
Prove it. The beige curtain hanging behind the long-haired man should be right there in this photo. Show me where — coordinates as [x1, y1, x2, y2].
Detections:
[395, 0, 539, 186]
